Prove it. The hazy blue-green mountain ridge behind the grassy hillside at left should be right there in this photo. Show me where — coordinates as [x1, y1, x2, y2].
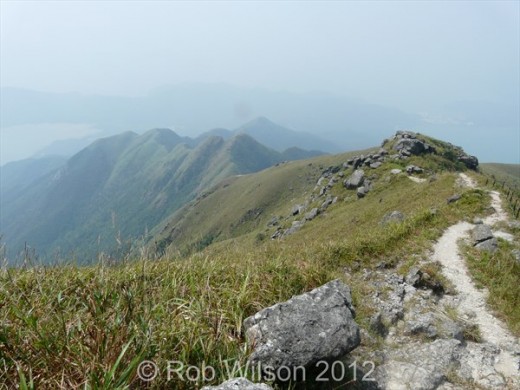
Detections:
[0, 122, 322, 261]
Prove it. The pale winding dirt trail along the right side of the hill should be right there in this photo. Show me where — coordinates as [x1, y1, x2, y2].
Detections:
[433, 173, 519, 377]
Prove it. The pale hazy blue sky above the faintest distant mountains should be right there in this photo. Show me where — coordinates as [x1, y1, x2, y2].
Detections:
[0, 0, 520, 163]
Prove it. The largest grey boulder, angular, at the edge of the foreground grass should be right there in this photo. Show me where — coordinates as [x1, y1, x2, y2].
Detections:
[244, 280, 360, 370]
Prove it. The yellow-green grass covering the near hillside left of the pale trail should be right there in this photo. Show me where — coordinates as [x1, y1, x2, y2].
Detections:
[0, 133, 500, 389]
